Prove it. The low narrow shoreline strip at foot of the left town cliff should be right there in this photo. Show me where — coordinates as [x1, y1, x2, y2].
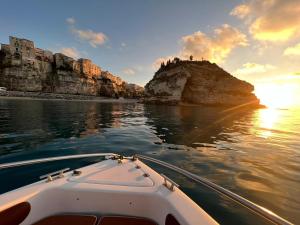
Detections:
[0, 91, 138, 103]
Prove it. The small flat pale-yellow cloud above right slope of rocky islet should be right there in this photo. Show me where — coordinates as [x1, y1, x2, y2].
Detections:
[234, 63, 276, 75]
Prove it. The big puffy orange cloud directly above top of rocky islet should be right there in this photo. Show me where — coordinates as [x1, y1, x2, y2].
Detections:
[180, 24, 247, 62]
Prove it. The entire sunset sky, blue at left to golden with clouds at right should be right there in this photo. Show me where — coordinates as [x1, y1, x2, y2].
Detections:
[0, 0, 300, 104]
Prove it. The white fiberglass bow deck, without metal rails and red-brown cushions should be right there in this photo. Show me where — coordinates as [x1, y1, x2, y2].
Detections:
[0, 159, 217, 225]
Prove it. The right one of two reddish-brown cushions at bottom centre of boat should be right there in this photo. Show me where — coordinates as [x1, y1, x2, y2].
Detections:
[98, 216, 157, 225]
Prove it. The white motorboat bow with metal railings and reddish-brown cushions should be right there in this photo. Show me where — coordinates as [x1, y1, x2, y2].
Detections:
[0, 153, 291, 225]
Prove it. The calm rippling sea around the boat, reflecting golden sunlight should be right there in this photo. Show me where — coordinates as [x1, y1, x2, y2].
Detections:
[0, 99, 300, 224]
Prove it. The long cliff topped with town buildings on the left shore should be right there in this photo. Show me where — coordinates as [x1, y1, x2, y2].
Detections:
[0, 37, 143, 98]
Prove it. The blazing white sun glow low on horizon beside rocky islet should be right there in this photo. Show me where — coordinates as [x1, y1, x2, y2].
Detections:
[255, 83, 297, 108]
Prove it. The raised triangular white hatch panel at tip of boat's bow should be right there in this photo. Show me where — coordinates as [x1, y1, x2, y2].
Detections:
[69, 160, 154, 187]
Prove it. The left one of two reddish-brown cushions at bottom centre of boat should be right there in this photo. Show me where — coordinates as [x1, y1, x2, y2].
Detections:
[33, 215, 97, 225]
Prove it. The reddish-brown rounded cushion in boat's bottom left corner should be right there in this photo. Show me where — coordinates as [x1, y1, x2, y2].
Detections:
[0, 202, 31, 225]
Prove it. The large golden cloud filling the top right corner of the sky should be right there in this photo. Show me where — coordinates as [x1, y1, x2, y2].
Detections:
[230, 0, 300, 42]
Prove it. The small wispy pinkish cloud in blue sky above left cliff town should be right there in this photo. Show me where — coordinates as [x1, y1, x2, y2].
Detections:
[66, 18, 108, 48]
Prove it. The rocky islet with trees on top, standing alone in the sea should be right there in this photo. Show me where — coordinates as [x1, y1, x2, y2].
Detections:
[144, 60, 259, 106]
